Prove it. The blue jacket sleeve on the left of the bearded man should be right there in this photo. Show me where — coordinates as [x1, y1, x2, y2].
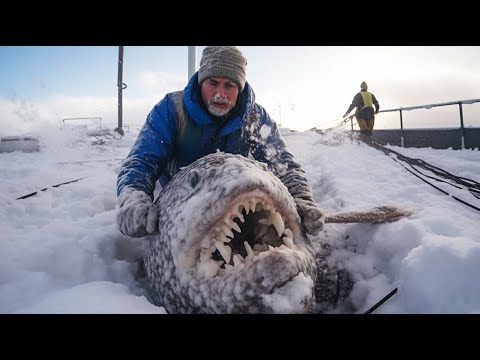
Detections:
[117, 95, 176, 200]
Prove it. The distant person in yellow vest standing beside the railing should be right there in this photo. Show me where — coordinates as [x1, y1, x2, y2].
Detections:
[343, 81, 380, 136]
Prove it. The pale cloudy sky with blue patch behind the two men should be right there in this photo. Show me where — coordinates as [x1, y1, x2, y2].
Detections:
[0, 46, 480, 135]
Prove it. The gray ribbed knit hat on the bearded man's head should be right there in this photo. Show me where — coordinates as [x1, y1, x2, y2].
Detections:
[198, 46, 247, 92]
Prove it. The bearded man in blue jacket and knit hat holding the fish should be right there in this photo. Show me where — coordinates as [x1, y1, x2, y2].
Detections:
[116, 46, 324, 237]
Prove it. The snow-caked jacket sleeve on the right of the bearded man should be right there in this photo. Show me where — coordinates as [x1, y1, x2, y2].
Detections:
[244, 104, 314, 201]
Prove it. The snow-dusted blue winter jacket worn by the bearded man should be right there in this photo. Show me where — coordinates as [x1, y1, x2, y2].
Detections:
[117, 73, 313, 200]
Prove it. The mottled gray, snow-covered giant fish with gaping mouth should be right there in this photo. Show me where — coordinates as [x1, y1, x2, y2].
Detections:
[143, 152, 317, 314]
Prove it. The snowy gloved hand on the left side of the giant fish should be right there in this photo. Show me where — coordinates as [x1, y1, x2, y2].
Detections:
[116, 188, 158, 238]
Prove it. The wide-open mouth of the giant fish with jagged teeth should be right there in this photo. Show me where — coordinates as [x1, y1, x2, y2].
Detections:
[197, 190, 299, 278]
